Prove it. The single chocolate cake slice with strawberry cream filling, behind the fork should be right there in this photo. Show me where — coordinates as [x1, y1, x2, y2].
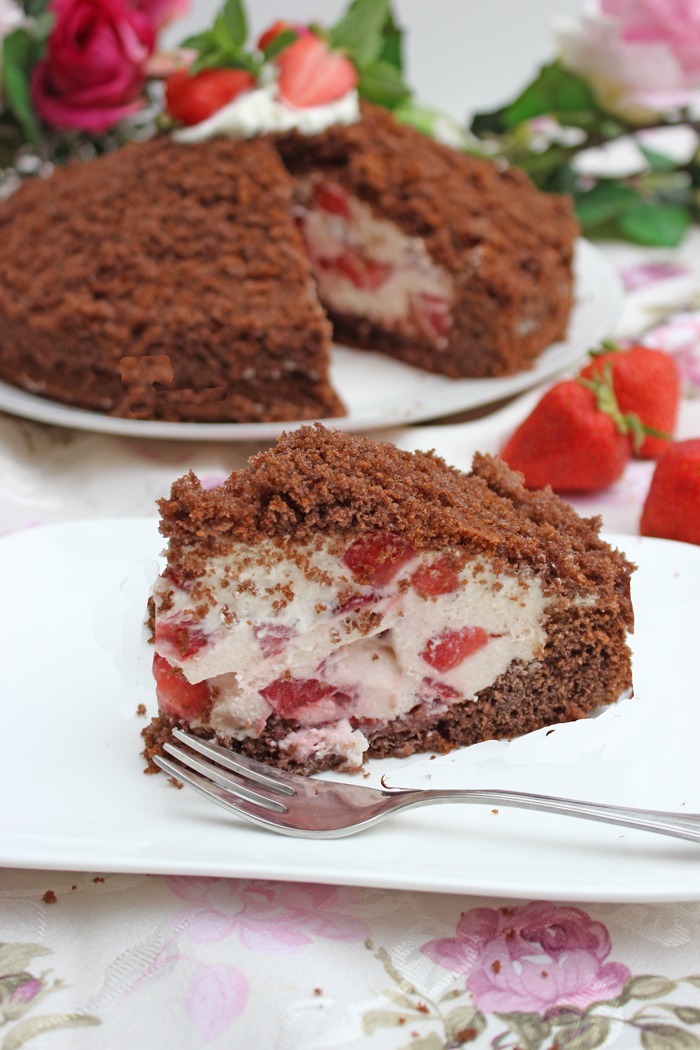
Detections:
[145, 424, 633, 773]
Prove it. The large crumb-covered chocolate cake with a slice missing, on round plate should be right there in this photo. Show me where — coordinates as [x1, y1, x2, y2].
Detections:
[0, 104, 576, 422]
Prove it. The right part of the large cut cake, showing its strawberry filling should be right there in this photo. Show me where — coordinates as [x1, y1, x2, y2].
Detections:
[278, 103, 577, 377]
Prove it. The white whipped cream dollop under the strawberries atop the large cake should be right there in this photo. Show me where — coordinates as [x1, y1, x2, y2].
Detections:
[172, 79, 360, 144]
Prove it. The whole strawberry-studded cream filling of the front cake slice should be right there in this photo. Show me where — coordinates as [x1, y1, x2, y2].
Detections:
[154, 534, 550, 765]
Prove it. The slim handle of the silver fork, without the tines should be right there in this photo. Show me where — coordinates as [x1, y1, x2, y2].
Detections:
[383, 788, 700, 842]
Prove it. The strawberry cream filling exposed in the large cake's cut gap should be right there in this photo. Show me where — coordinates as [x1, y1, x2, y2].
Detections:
[297, 176, 453, 345]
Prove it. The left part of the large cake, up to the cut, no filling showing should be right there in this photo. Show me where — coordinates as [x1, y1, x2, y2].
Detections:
[0, 137, 344, 422]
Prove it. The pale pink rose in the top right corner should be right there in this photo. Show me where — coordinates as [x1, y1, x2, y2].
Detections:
[558, 0, 700, 124]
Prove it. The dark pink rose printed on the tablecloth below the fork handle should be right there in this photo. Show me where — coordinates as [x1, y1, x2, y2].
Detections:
[421, 902, 630, 1014]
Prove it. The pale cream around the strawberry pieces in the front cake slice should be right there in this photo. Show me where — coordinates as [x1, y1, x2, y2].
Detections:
[154, 543, 550, 747]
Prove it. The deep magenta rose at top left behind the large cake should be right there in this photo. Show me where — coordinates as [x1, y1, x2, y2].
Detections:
[31, 0, 155, 134]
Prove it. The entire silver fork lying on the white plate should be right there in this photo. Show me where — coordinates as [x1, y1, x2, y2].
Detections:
[154, 729, 700, 842]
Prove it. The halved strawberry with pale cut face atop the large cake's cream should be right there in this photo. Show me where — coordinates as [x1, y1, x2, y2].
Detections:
[276, 34, 357, 109]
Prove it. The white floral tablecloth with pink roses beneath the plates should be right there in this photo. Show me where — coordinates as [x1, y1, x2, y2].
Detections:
[0, 233, 700, 1050]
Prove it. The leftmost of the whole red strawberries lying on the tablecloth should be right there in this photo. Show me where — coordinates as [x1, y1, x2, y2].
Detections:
[501, 379, 631, 492]
